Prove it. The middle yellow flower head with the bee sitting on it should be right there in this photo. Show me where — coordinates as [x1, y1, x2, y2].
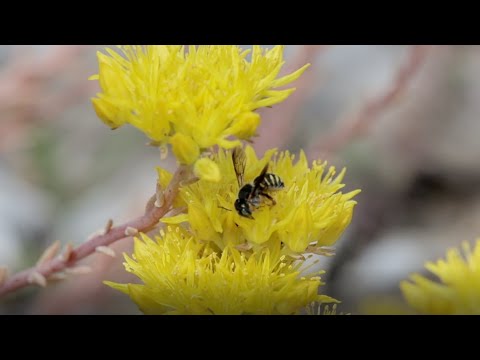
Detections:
[162, 146, 359, 254]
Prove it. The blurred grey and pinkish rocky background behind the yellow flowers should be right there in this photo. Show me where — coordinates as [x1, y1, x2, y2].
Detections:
[0, 45, 480, 314]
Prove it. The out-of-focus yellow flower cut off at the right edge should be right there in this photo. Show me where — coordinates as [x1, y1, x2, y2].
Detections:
[400, 239, 480, 315]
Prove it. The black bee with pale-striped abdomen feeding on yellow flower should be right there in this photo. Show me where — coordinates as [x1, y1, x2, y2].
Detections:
[232, 147, 285, 219]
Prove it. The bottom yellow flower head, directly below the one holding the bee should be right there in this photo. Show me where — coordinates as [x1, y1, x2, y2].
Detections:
[105, 227, 336, 314]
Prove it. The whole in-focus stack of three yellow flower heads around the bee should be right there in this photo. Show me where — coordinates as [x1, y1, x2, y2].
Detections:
[96, 45, 359, 314]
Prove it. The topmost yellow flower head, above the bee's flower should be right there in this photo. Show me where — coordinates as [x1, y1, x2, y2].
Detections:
[91, 45, 308, 167]
